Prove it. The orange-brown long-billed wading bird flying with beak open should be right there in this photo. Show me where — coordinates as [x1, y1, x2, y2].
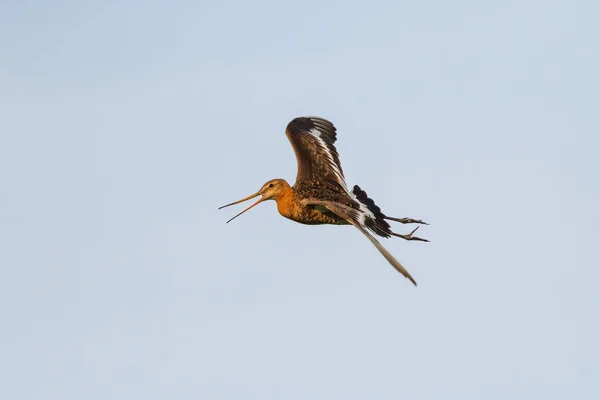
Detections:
[219, 117, 428, 286]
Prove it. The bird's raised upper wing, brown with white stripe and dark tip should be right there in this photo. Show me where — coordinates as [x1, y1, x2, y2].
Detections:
[285, 117, 349, 192]
